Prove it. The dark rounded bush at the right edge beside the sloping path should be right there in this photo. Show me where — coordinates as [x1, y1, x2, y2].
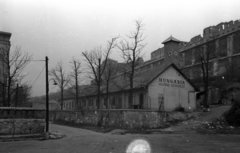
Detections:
[224, 100, 240, 126]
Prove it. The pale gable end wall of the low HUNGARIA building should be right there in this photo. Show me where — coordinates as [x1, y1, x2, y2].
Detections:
[148, 67, 196, 111]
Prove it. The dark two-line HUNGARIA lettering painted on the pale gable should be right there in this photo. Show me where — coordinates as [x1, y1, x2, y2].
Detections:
[158, 78, 185, 88]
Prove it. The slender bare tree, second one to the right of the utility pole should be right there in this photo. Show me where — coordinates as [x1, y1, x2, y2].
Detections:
[70, 58, 82, 109]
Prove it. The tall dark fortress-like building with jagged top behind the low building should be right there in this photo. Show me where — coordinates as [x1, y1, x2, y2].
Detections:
[138, 20, 240, 103]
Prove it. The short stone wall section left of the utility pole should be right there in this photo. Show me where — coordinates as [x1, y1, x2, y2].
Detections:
[0, 107, 45, 135]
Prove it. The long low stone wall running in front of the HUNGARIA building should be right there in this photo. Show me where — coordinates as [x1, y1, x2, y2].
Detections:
[49, 110, 189, 129]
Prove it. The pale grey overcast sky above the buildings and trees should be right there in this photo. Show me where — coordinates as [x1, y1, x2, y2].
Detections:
[0, 0, 240, 96]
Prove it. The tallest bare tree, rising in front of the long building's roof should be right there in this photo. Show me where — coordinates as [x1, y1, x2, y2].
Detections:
[118, 20, 146, 109]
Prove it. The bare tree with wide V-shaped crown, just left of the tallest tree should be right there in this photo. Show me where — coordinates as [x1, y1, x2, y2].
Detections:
[82, 37, 118, 109]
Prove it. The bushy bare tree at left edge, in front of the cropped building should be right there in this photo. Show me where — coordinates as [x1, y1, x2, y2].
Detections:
[0, 45, 32, 106]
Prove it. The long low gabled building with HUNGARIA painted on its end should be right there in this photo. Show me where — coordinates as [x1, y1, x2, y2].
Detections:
[76, 63, 197, 111]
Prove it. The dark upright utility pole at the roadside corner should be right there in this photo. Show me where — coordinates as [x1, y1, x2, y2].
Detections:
[45, 56, 49, 133]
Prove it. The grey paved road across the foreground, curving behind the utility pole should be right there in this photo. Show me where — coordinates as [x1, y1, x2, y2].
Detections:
[0, 124, 240, 153]
